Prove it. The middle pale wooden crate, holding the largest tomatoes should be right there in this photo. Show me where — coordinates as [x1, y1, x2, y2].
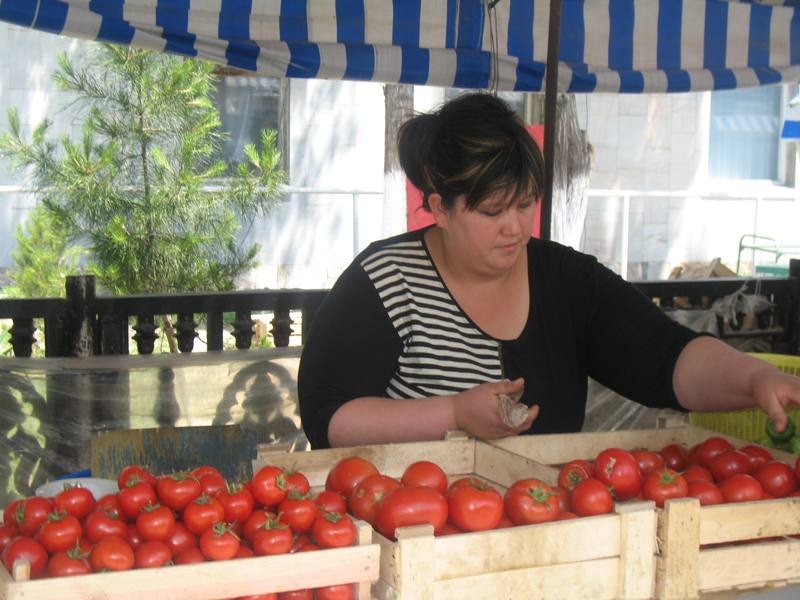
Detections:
[253, 435, 656, 600]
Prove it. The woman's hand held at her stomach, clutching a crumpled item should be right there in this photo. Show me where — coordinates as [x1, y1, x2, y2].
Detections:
[453, 378, 539, 439]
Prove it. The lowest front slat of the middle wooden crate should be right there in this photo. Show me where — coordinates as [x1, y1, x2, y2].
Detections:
[433, 558, 620, 600]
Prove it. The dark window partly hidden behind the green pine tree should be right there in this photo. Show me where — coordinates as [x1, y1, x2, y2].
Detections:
[214, 74, 289, 170]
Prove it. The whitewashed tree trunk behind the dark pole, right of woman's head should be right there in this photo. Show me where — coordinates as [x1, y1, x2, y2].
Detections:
[529, 94, 592, 250]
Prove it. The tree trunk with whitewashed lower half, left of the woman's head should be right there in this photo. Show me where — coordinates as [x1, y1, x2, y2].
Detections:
[381, 83, 414, 237]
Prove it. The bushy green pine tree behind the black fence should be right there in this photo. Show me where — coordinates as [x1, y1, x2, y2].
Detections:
[0, 45, 286, 294]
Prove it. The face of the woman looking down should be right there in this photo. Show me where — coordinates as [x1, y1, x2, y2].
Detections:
[436, 195, 536, 274]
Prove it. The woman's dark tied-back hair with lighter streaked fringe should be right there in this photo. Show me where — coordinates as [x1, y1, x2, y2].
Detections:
[397, 93, 544, 210]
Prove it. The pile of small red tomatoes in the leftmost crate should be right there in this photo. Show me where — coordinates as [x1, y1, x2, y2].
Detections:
[0, 465, 357, 600]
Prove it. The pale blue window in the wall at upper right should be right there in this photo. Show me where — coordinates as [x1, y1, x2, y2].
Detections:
[708, 86, 782, 181]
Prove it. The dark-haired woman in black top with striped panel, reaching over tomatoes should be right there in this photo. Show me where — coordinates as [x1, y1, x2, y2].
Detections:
[298, 94, 800, 448]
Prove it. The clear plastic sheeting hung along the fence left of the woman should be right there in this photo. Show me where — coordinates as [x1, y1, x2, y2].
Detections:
[0, 347, 308, 506]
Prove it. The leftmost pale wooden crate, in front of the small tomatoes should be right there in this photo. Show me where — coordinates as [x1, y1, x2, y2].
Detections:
[0, 521, 380, 600]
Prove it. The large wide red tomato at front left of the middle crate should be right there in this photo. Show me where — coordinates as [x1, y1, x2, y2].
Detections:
[375, 487, 447, 539]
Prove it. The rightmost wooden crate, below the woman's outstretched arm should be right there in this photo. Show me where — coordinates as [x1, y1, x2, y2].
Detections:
[491, 425, 800, 599]
